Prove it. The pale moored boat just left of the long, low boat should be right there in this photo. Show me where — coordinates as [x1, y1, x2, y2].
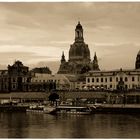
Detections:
[26, 105, 56, 114]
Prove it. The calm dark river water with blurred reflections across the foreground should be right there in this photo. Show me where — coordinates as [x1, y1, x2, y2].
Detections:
[0, 113, 140, 138]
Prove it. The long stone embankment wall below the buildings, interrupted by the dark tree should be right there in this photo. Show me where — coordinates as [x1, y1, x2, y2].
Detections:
[0, 91, 140, 103]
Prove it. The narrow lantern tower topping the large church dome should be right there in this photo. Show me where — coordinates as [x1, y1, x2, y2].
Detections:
[75, 21, 84, 42]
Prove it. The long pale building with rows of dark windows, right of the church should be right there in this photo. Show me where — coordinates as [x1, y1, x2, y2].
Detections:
[86, 69, 140, 90]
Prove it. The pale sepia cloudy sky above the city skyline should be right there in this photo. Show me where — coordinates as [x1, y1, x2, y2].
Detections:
[0, 2, 140, 73]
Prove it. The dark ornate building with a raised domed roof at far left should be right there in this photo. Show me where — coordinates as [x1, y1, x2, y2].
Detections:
[0, 61, 31, 92]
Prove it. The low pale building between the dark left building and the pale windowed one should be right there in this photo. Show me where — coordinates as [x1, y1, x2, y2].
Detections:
[29, 73, 74, 91]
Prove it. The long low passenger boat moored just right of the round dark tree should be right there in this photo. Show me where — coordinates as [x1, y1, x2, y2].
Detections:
[56, 106, 92, 115]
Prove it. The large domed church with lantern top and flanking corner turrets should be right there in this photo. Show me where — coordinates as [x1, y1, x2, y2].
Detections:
[58, 22, 99, 74]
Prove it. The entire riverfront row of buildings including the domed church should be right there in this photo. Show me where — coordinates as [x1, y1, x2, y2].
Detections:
[0, 22, 140, 92]
